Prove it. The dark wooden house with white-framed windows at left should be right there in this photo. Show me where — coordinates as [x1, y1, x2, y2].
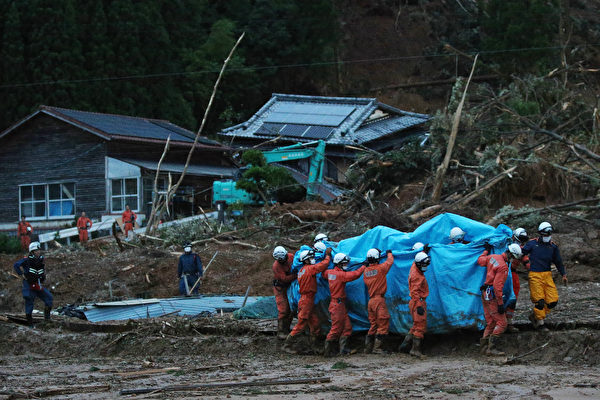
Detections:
[0, 106, 236, 233]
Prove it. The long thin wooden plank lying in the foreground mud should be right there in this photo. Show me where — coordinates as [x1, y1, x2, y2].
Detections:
[119, 376, 331, 396]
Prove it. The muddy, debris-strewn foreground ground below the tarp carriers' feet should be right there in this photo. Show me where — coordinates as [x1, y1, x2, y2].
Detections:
[0, 276, 600, 399]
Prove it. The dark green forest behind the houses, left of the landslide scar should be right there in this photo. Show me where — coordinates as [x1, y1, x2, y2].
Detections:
[0, 0, 338, 133]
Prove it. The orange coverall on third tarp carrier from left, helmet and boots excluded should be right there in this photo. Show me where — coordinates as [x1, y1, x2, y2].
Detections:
[323, 265, 365, 340]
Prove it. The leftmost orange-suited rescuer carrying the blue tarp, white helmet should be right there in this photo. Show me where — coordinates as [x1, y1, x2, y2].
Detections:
[273, 246, 298, 340]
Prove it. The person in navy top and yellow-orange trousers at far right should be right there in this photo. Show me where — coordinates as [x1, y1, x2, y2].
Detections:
[523, 222, 567, 331]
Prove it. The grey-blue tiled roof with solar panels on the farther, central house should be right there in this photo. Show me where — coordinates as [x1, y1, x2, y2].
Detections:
[219, 93, 430, 145]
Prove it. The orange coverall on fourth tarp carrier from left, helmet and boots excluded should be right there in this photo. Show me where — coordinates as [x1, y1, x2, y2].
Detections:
[363, 253, 394, 335]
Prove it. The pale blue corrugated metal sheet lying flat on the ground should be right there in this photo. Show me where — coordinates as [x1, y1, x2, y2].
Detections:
[83, 296, 257, 322]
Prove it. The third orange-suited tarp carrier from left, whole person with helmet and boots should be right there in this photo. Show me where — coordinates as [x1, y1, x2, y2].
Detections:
[323, 253, 366, 357]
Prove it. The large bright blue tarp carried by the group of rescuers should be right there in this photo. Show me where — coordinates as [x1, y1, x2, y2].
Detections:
[288, 213, 515, 334]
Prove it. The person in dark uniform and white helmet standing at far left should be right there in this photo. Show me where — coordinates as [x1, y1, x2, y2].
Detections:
[13, 242, 53, 325]
